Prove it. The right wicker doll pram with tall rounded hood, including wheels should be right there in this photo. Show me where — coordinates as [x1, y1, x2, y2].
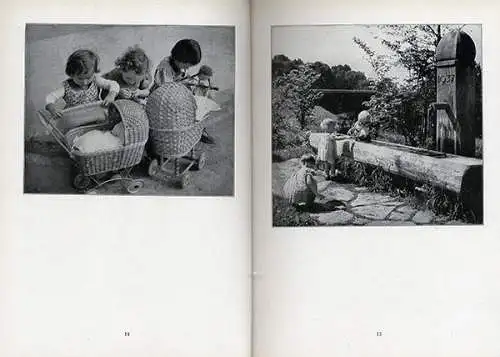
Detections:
[146, 83, 206, 188]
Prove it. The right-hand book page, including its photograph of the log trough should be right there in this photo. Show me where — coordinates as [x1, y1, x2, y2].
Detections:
[252, 0, 500, 357]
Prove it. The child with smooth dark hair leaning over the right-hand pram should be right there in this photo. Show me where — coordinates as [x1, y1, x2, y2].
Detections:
[151, 39, 201, 92]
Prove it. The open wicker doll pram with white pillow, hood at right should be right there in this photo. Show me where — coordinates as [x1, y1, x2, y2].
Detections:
[38, 100, 149, 193]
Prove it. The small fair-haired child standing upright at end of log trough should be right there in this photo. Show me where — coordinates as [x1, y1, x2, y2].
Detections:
[316, 118, 337, 180]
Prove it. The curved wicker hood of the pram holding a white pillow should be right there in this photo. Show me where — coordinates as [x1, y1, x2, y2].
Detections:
[109, 99, 149, 146]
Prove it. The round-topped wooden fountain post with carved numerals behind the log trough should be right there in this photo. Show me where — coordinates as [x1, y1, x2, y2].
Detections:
[435, 30, 476, 156]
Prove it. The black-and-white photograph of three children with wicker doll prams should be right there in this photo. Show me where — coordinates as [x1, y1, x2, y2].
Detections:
[24, 24, 235, 196]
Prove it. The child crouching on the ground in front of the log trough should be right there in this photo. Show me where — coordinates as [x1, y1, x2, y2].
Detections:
[283, 154, 323, 210]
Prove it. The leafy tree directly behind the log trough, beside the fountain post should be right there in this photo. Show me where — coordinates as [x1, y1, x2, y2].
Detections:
[353, 25, 476, 146]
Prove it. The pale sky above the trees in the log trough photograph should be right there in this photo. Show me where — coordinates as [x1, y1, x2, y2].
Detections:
[271, 24, 482, 79]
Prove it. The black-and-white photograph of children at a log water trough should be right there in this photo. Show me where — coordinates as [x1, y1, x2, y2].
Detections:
[271, 24, 483, 227]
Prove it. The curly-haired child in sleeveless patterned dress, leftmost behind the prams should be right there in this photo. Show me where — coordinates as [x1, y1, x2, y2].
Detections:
[45, 49, 120, 118]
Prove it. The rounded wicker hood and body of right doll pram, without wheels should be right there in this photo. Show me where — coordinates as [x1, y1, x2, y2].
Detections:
[146, 83, 203, 157]
